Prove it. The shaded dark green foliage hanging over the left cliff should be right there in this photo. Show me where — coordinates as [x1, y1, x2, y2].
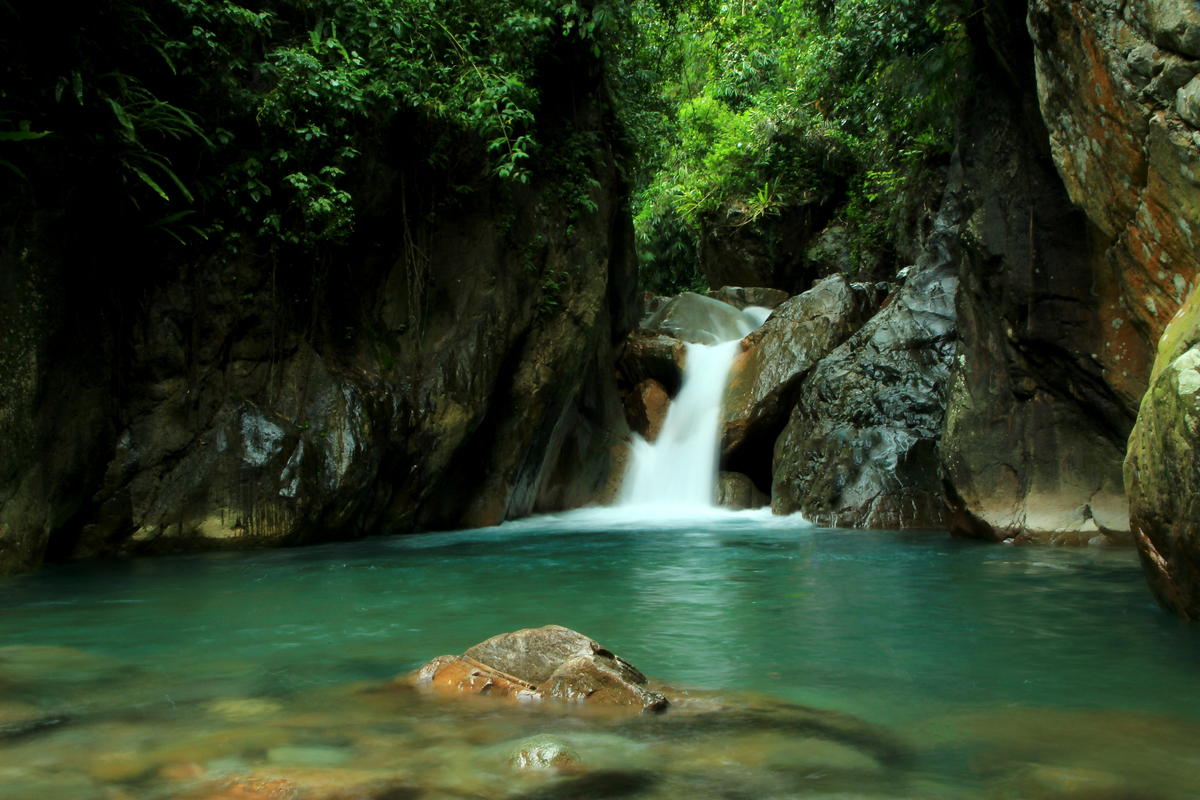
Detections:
[0, 0, 614, 248]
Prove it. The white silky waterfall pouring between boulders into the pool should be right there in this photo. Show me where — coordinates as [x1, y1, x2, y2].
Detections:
[620, 295, 770, 509]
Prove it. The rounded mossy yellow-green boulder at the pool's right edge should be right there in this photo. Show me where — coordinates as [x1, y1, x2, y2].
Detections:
[1124, 293, 1200, 620]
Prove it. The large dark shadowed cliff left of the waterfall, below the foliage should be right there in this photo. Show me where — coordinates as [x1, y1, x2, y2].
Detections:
[0, 38, 636, 572]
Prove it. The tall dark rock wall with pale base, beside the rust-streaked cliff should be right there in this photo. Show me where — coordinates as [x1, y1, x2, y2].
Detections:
[941, 10, 1132, 543]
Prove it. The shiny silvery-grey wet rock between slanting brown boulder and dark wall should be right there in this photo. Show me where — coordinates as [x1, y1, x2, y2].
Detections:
[770, 192, 959, 528]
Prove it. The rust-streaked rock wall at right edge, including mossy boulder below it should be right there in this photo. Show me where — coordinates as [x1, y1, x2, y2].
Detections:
[1028, 0, 1200, 616]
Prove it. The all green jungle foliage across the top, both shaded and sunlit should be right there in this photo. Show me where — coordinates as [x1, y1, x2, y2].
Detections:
[0, 0, 967, 289]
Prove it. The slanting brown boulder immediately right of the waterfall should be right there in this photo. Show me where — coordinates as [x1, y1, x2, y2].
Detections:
[721, 275, 878, 474]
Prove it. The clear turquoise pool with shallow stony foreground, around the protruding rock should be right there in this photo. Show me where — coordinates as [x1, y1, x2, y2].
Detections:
[0, 509, 1200, 800]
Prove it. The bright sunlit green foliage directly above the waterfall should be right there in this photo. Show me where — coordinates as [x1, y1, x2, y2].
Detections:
[622, 0, 971, 293]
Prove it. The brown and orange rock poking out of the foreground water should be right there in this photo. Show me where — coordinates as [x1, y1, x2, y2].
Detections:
[414, 625, 667, 712]
